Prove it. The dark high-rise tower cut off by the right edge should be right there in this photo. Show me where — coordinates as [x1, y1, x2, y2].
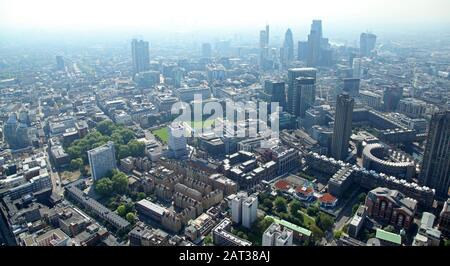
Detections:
[419, 110, 450, 200]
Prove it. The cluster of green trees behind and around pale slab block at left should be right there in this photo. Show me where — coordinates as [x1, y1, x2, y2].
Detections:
[66, 120, 145, 166]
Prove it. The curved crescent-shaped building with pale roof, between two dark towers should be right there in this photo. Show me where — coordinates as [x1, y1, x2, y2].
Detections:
[362, 143, 416, 179]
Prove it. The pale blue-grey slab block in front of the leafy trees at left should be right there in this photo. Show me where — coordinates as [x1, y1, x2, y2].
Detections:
[88, 141, 117, 181]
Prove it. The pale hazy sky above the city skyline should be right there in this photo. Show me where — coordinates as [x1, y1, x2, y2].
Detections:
[0, 0, 450, 30]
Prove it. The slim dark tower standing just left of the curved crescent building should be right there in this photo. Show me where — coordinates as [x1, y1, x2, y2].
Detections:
[331, 94, 355, 160]
